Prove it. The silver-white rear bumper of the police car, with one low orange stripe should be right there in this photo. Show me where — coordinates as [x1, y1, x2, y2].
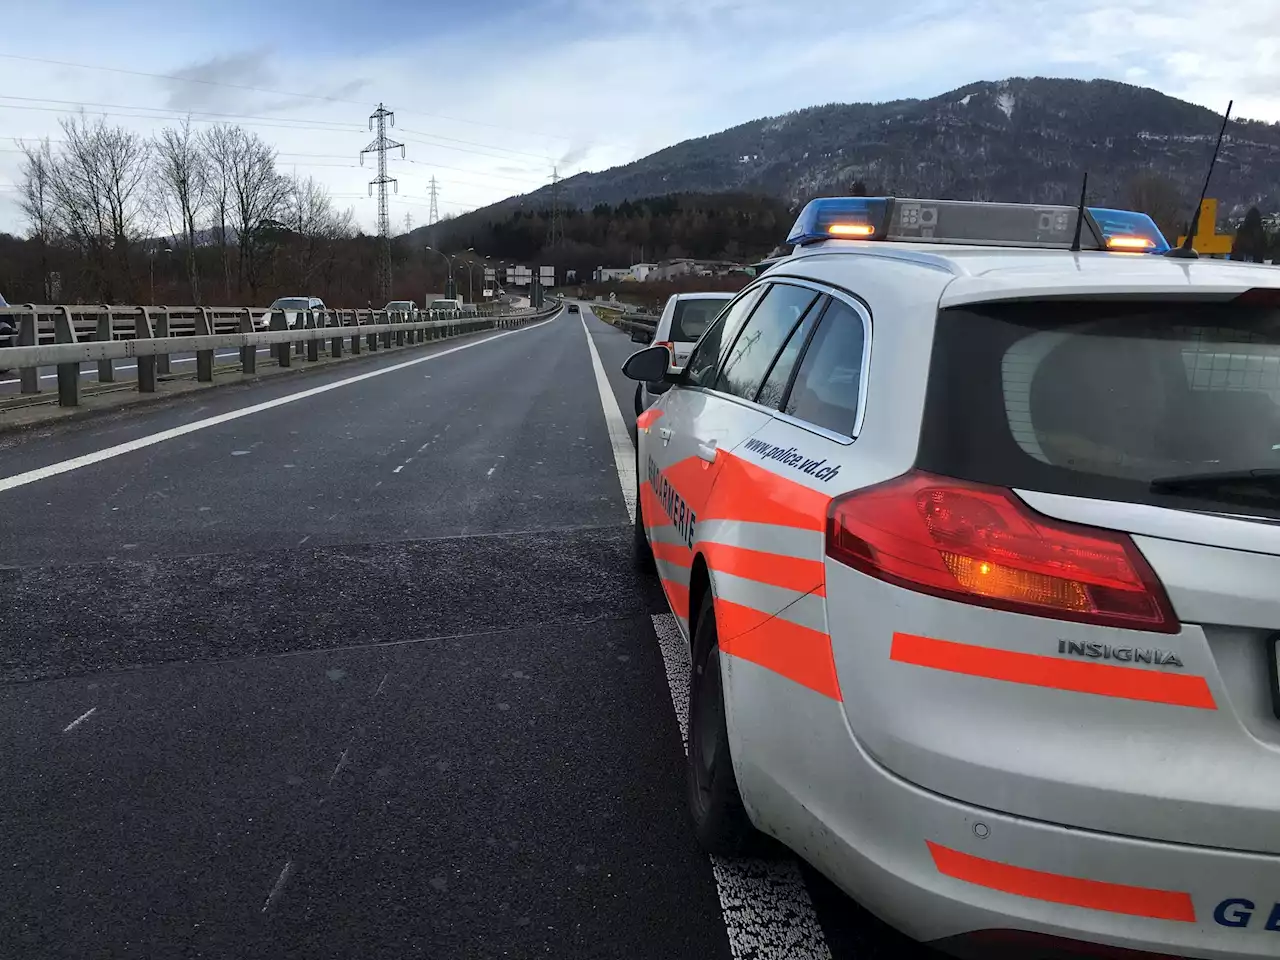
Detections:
[730, 658, 1280, 960]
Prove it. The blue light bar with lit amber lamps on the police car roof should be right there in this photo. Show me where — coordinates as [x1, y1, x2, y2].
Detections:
[787, 197, 1169, 253]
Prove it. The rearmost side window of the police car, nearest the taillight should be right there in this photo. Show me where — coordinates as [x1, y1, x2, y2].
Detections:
[783, 301, 867, 436]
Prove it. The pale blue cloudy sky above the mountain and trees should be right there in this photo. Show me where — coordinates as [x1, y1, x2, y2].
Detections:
[0, 0, 1280, 233]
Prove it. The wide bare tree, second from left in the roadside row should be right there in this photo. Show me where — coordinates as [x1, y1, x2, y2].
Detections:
[40, 114, 151, 301]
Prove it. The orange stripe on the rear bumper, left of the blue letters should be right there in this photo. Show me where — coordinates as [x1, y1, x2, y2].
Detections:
[925, 841, 1196, 923]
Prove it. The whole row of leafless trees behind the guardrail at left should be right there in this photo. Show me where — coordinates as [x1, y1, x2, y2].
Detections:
[4, 114, 356, 303]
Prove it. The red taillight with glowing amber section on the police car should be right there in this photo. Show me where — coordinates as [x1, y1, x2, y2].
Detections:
[827, 471, 1179, 634]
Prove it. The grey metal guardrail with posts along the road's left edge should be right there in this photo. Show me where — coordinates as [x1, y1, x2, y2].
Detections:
[0, 303, 559, 410]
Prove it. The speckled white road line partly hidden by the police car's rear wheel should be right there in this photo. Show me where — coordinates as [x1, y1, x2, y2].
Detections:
[653, 613, 831, 960]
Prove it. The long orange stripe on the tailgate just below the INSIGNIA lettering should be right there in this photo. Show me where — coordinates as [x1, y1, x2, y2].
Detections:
[890, 634, 1217, 710]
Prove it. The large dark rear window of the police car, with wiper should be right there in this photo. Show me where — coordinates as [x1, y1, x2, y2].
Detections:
[918, 301, 1280, 517]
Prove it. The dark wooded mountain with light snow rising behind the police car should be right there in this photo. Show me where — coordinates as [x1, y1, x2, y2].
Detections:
[419, 77, 1280, 249]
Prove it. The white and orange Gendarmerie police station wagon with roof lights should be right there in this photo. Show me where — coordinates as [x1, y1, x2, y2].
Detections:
[625, 198, 1280, 957]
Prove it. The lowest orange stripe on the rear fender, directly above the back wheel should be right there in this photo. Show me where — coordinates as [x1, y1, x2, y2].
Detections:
[716, 593, 841, 700]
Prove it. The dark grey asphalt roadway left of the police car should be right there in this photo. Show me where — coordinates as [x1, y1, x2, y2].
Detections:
[0, 305, 936, 960]
